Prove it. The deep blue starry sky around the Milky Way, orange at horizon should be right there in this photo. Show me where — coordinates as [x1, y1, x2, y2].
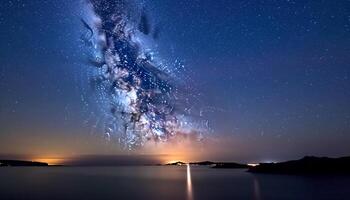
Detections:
[0, 0, 350, 162]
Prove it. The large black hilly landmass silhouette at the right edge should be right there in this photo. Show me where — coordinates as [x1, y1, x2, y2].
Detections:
[248, 156, 350, 174]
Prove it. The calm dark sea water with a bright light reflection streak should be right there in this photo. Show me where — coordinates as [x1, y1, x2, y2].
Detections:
[0, 166, 350, 200]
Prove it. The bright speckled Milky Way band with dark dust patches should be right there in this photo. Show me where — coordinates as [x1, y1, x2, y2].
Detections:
[82, 0, 207, 149]
